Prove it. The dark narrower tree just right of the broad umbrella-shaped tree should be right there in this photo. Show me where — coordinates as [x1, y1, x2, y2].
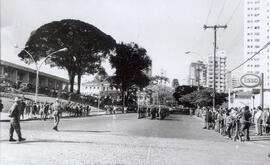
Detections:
[110, 43, 152, 105]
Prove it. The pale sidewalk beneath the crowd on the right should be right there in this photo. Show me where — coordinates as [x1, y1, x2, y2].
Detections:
[193, 115, 270, 147]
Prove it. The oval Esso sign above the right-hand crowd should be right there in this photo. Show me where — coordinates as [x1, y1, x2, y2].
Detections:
[240, 74, 261, 88]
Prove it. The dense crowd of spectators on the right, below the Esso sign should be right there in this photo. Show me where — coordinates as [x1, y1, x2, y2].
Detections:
[195, 106, 270, 141]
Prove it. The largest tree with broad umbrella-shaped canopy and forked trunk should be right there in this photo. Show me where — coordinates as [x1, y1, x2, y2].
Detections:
[18, 19, 115, 93]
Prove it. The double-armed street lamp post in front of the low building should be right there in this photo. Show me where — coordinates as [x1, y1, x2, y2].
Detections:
[19, 48, 68, 102]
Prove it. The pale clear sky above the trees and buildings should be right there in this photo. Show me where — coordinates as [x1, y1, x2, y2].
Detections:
[1, 0, 244, 83]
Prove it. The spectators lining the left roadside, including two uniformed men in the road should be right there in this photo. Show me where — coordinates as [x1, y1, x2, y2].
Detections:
[4, 97, 94, 142]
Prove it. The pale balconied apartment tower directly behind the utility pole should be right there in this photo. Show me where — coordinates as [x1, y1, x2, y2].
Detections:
[207, 51, 227, 93]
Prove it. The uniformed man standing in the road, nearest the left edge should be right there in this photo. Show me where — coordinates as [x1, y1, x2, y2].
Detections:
[9, 97, 25, 142]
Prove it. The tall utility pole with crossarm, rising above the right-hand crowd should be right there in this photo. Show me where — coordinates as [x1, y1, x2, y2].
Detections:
[203, 25, 227, 110]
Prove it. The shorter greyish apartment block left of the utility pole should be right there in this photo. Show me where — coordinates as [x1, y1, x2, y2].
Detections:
[188, 61, 207, 87]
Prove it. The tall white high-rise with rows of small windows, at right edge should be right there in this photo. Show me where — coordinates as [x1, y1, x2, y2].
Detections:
[244, 0, 270, 89]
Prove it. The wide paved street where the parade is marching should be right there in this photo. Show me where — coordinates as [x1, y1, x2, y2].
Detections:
[0, 114, 270, 165]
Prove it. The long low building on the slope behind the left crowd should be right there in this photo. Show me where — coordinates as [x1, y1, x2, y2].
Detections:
[0, 60, 69, 92]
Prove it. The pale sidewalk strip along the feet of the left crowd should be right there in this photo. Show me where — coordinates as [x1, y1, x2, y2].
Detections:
[0, 110, 106, 122]
